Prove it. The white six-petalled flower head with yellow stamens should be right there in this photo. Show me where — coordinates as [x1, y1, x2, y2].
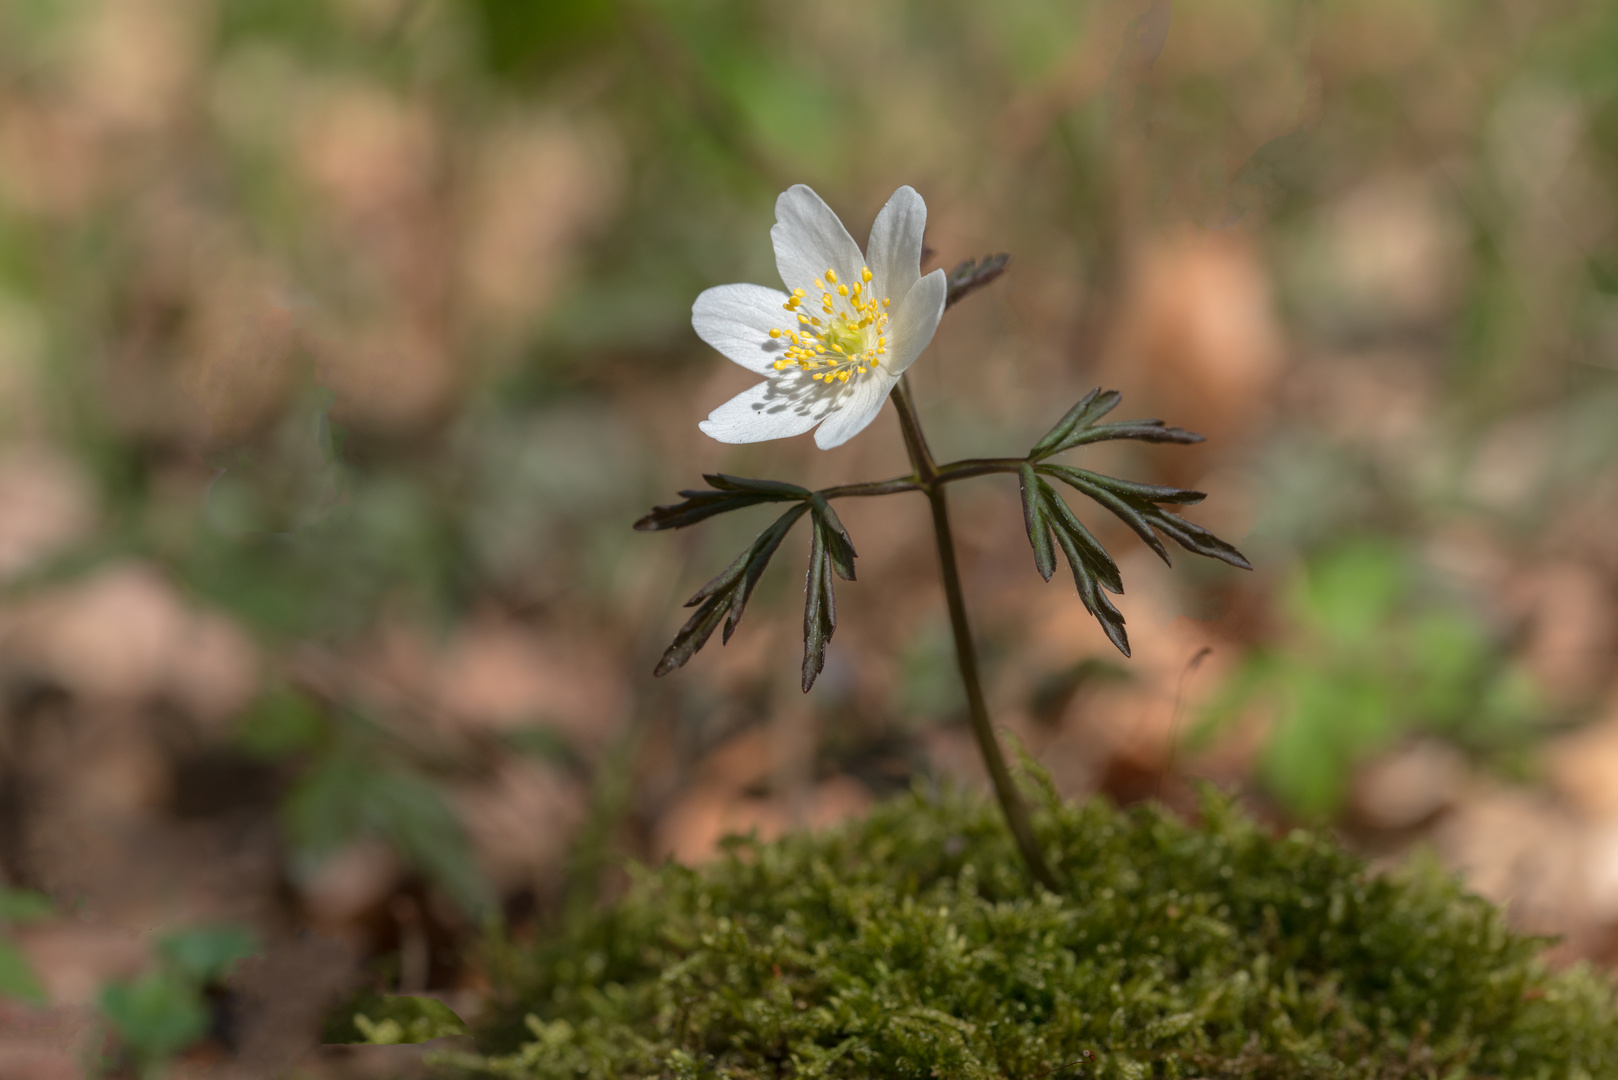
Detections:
[691, 185, 947, 450]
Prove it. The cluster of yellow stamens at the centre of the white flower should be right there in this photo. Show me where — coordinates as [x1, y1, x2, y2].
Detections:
[770, 267, 890, 382]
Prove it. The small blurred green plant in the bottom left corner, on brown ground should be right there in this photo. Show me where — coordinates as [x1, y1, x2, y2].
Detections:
[100, 925, 259, 1077]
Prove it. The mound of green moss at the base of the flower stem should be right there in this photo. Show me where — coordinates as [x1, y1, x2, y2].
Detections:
[446, 795, 1618, 1080]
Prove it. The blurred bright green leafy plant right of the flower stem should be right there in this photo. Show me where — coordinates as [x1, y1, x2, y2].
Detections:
[1189, 539, 1535, 819]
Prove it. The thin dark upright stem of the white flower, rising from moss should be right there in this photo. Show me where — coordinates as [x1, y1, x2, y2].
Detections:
[893, 376, 1060, 892]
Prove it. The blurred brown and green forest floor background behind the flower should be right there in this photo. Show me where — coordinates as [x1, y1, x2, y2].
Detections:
[0, 0, 1618, 1080]
